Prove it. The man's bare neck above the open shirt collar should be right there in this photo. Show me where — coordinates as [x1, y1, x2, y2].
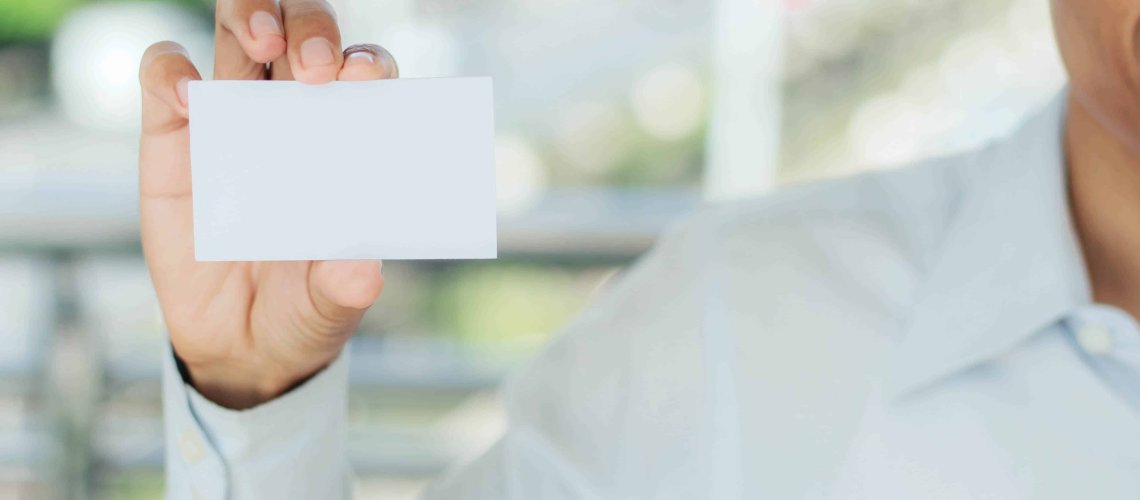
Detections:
[1065, 97, 1140, 318]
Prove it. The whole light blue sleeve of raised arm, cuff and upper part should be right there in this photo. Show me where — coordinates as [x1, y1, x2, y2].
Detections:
[164, 212, 720, 500]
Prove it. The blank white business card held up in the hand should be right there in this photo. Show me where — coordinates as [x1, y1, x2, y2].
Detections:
[189, 77, 497, 261]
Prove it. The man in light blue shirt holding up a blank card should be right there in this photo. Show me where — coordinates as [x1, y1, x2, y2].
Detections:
[140, 0, 1140, 500]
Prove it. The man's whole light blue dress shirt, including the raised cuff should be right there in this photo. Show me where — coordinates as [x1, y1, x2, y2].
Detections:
[164, 91, 1140, 500]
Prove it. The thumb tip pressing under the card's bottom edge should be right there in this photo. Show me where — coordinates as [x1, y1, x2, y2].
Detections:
[309, 261, 384, 326]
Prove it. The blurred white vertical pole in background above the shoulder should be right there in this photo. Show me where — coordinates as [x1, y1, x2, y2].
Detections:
[705, 0, 783, 200]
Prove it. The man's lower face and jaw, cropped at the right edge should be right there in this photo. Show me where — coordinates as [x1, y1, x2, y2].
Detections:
[1052, 0, 1140, 154]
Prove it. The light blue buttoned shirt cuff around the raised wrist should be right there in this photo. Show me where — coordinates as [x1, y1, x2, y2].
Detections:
[163, 345, 352, 500]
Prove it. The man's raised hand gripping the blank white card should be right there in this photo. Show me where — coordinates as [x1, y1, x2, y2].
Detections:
[139, 0, 398, 409]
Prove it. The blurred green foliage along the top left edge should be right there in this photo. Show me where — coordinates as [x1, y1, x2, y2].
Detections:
[0, 0, 213, 43]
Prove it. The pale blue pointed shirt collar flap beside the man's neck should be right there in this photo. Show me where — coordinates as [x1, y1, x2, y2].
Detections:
[886, 92, 1091, 397]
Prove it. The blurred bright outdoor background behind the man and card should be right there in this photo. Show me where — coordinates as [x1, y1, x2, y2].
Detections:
[0, 0, 1064, 499]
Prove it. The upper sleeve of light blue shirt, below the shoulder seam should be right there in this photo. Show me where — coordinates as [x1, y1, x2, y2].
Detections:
[424, 216, 725, 500]
